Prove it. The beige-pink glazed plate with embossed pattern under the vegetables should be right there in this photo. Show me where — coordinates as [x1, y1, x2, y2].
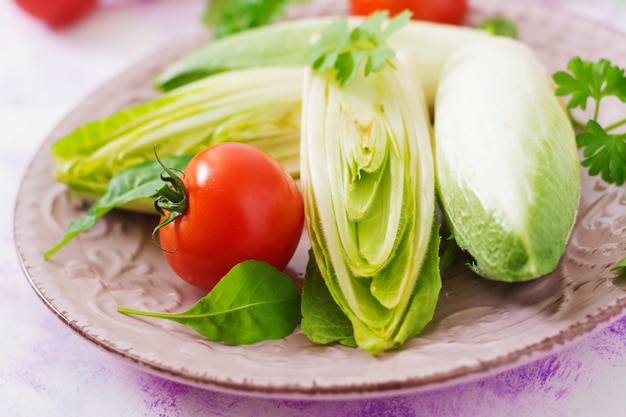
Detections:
[15, 1, 626, 398]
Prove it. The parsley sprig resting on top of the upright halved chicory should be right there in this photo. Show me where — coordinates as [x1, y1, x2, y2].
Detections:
[305, 11, 411, 86]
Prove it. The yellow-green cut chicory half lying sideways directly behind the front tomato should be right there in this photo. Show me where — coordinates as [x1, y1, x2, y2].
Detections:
[52, 67, 302, 208]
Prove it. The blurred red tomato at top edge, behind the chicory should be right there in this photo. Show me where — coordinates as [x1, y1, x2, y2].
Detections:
[350, 0, 468, 25]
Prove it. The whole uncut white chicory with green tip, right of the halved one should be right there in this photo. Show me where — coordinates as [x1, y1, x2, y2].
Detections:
[434, 37, 580, 281]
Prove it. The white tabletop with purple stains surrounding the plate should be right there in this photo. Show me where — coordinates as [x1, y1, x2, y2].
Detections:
[0, 0, 626, 417]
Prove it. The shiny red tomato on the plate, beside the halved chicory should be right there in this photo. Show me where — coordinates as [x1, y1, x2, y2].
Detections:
[158, 142, 304, 290]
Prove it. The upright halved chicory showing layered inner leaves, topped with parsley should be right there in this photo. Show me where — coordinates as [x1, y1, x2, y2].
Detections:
[301, 51, 441, 355]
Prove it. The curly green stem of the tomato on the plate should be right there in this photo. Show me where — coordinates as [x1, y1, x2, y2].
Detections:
[152, 145, 187, 253]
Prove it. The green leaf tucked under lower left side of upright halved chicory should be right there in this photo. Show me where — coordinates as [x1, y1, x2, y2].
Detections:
[301, 252, 356, 347]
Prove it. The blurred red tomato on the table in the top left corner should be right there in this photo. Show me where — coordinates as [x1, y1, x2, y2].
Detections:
[15, 0, 98, 27]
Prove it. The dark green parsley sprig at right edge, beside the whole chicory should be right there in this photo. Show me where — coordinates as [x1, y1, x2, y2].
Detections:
[553, 57, 626, 185]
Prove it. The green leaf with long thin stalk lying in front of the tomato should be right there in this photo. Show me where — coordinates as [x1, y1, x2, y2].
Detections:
[118, 260, 301, 345]
